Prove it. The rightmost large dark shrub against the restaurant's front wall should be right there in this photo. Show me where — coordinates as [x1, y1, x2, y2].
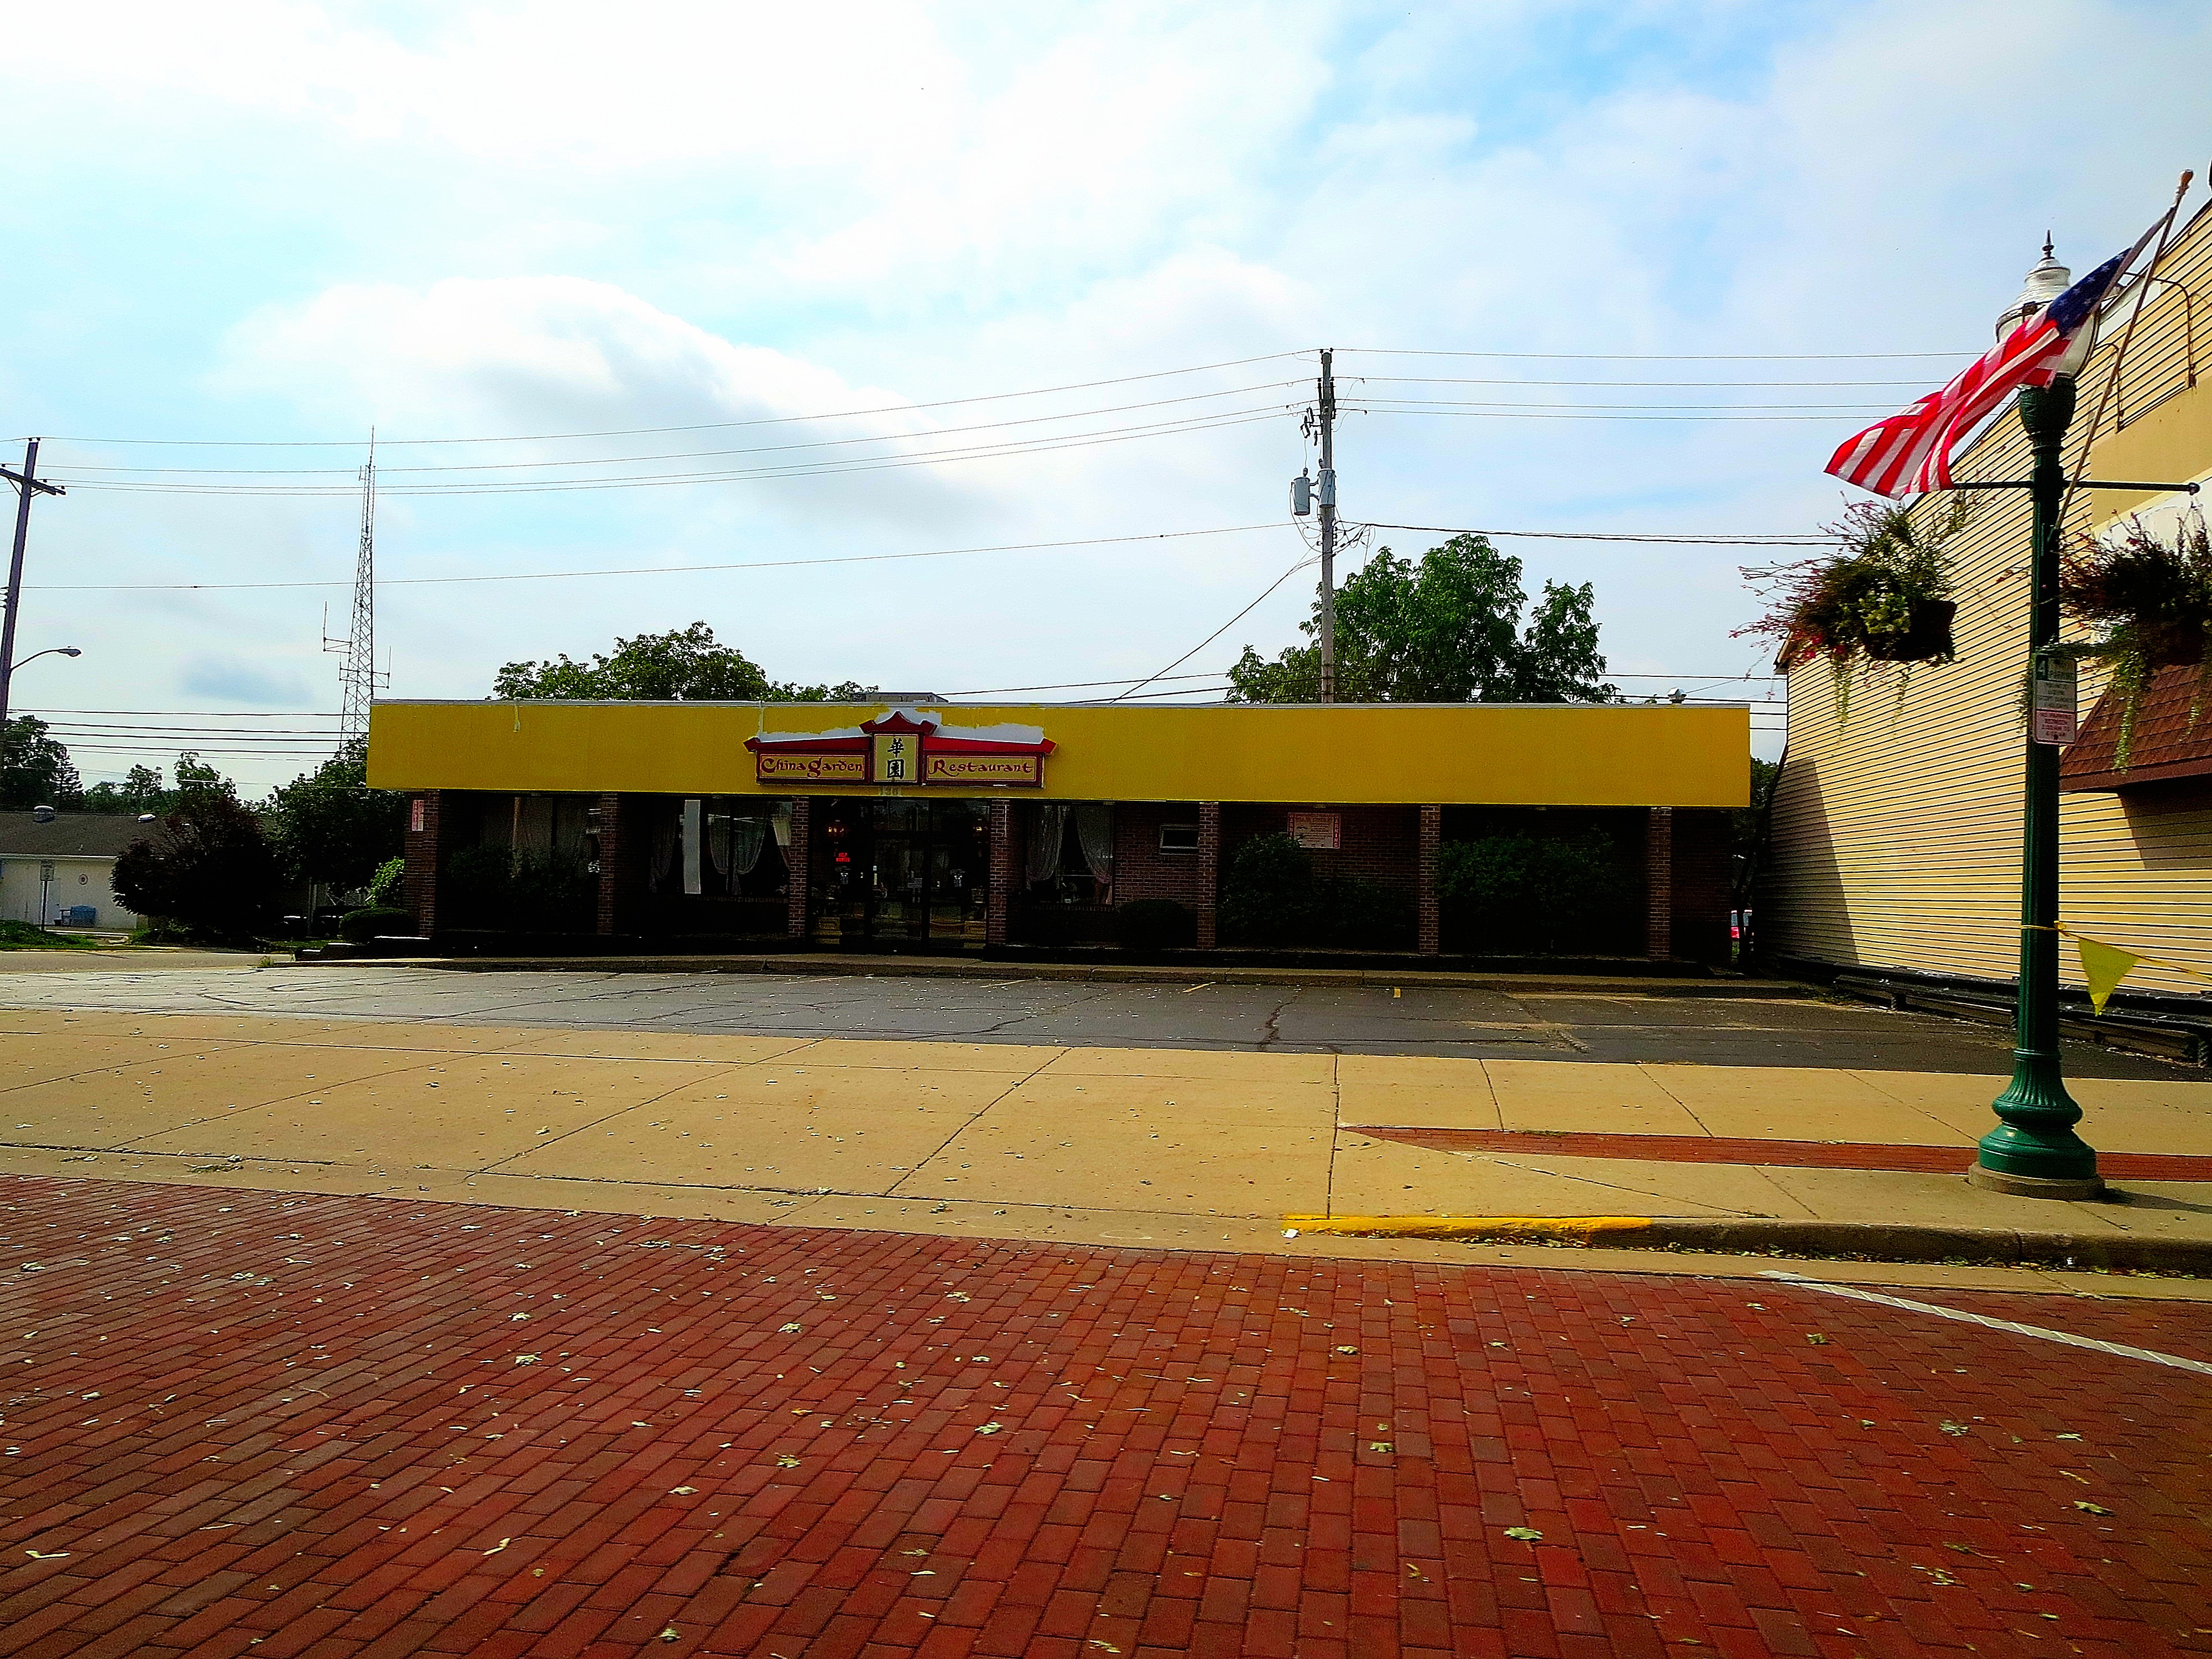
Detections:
[1438, 830, 1637, 953]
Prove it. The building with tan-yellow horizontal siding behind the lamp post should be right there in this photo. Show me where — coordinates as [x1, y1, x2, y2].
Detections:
[1759, 208, 2212, 993]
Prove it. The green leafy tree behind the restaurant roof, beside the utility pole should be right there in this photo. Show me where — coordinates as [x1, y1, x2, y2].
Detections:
[1230, 535, 1617, 703]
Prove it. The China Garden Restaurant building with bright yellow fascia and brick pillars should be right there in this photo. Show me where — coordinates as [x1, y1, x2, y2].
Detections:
[369, 697, 1750, 960]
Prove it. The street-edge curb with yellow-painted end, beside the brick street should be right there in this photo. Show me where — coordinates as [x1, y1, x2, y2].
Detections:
[1283, 1214, 2212, 1276]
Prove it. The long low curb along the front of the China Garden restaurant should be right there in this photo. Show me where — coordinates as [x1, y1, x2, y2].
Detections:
[274, 951, 1820, 1000]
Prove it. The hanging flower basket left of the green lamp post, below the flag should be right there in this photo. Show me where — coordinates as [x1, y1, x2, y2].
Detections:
[1736, 495, 1971, 717]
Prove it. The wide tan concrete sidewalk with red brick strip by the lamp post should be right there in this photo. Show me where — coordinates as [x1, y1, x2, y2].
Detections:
[0, 1011, 2212, 1290]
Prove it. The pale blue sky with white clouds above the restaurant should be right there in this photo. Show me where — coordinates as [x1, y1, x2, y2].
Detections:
[0, 0, 2212, 792]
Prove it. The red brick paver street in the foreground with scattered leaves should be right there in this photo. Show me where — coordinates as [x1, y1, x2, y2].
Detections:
[0, 1179, 2212, 1659]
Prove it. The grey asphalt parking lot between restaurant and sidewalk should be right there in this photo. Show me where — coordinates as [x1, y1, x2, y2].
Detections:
[0, 960, 2199, 1079]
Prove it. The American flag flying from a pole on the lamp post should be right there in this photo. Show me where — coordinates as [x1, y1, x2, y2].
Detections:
[1827, 226, 2157, 495]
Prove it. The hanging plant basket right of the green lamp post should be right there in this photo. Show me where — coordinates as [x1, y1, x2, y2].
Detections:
[2059, 511, 2212, 772]
